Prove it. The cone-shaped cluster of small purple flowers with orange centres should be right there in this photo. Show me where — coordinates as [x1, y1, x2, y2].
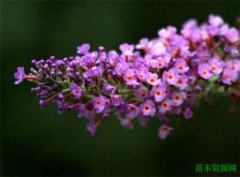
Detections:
[14, 15, 240, 139]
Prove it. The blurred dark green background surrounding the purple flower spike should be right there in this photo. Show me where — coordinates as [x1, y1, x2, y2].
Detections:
[0, 1, 240, 176]
